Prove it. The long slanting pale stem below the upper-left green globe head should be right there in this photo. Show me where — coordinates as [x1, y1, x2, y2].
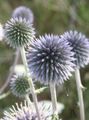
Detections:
[20, 47, 41, 120]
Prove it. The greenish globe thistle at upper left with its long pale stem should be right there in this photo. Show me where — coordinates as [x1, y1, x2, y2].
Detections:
[4, 6, 41, 120]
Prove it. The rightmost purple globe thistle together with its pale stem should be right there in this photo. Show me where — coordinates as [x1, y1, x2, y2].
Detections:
[61, 30, 89, 120]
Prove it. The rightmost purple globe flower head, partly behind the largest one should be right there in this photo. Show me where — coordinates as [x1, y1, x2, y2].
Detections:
[61, 31, 89, 68]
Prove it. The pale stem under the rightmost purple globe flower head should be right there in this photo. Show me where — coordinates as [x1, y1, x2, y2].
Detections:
[75, 68, 85, 120]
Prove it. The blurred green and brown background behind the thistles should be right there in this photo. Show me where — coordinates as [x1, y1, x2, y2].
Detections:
[0, 0, 89, 120]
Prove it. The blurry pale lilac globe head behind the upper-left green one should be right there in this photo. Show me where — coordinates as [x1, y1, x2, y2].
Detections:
[12, 6, 34, 23]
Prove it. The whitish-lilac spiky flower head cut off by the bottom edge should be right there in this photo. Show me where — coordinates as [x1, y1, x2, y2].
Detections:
[3, 101, 52, 120]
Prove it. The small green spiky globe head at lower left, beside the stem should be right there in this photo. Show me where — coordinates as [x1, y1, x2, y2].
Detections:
[10, 74, 29, 97]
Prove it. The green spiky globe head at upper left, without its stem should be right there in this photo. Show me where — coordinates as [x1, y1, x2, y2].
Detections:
[4, 17, 35, 48]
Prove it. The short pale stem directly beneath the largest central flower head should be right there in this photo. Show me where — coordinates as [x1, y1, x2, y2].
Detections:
[50, 83, 57, 115]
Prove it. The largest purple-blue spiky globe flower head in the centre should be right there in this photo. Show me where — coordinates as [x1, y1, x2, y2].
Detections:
[26, 35, 74, 84]
